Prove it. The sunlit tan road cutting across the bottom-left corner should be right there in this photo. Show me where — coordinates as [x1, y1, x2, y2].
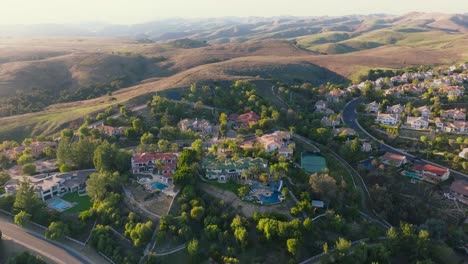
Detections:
[0, 219, 86, 264]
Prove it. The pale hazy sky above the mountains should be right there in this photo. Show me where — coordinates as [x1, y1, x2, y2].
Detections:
[0, 0, 468, 24]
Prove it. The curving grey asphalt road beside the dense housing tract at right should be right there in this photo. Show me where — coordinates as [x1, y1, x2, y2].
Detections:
[343, 98, 468, 180]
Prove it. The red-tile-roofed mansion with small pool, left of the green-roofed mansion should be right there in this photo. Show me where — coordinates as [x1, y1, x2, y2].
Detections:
[131, 152, 178, 183]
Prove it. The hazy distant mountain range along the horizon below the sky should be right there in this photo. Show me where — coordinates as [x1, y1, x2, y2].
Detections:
[0, 12, 468, 40]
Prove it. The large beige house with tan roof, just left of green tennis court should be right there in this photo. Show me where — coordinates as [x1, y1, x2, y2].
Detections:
[257, 131, 295, 158]
